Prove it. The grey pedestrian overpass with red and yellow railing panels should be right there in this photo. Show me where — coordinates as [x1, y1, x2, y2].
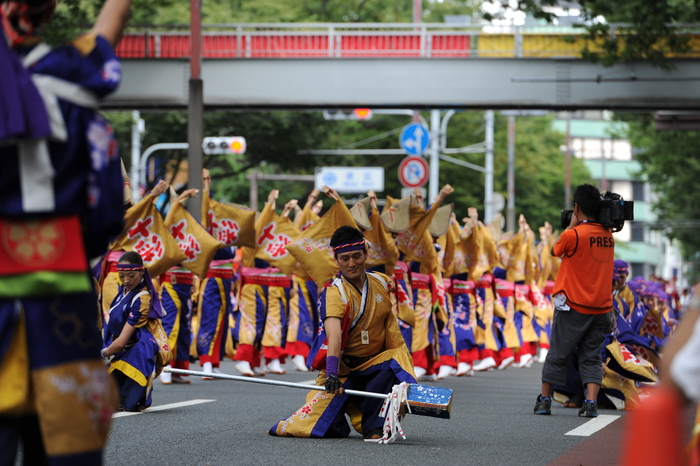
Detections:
[104, 23, 700, 111]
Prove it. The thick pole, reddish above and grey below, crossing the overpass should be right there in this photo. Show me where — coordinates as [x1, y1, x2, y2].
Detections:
[187, 0, 204, 220]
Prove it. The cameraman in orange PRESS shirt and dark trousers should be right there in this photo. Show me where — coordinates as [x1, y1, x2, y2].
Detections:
[534, 184, 615, 417]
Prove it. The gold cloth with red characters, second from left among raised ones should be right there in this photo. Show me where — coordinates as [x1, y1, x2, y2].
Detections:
[165, 202, 224, 280]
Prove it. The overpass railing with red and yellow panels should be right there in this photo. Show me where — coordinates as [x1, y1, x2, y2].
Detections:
[117, 23, 700, 58]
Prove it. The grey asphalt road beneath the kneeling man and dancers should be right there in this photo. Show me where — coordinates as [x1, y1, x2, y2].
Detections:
[105, 361, 624, 466]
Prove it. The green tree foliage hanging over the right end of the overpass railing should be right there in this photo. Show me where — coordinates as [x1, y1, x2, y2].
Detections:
[494, 0, 700, 68]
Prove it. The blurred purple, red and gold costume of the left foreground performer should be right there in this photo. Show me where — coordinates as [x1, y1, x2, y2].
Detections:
[0, 32, 123, 464]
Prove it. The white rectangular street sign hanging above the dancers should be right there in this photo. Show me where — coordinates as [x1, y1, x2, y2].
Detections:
[315, 167, 384, 193]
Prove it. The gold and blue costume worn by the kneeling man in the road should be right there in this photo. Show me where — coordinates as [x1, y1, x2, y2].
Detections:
[269, 273, 416, 438]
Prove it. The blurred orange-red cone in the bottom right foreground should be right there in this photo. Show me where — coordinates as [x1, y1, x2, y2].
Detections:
[620, 386, 685, 466]
